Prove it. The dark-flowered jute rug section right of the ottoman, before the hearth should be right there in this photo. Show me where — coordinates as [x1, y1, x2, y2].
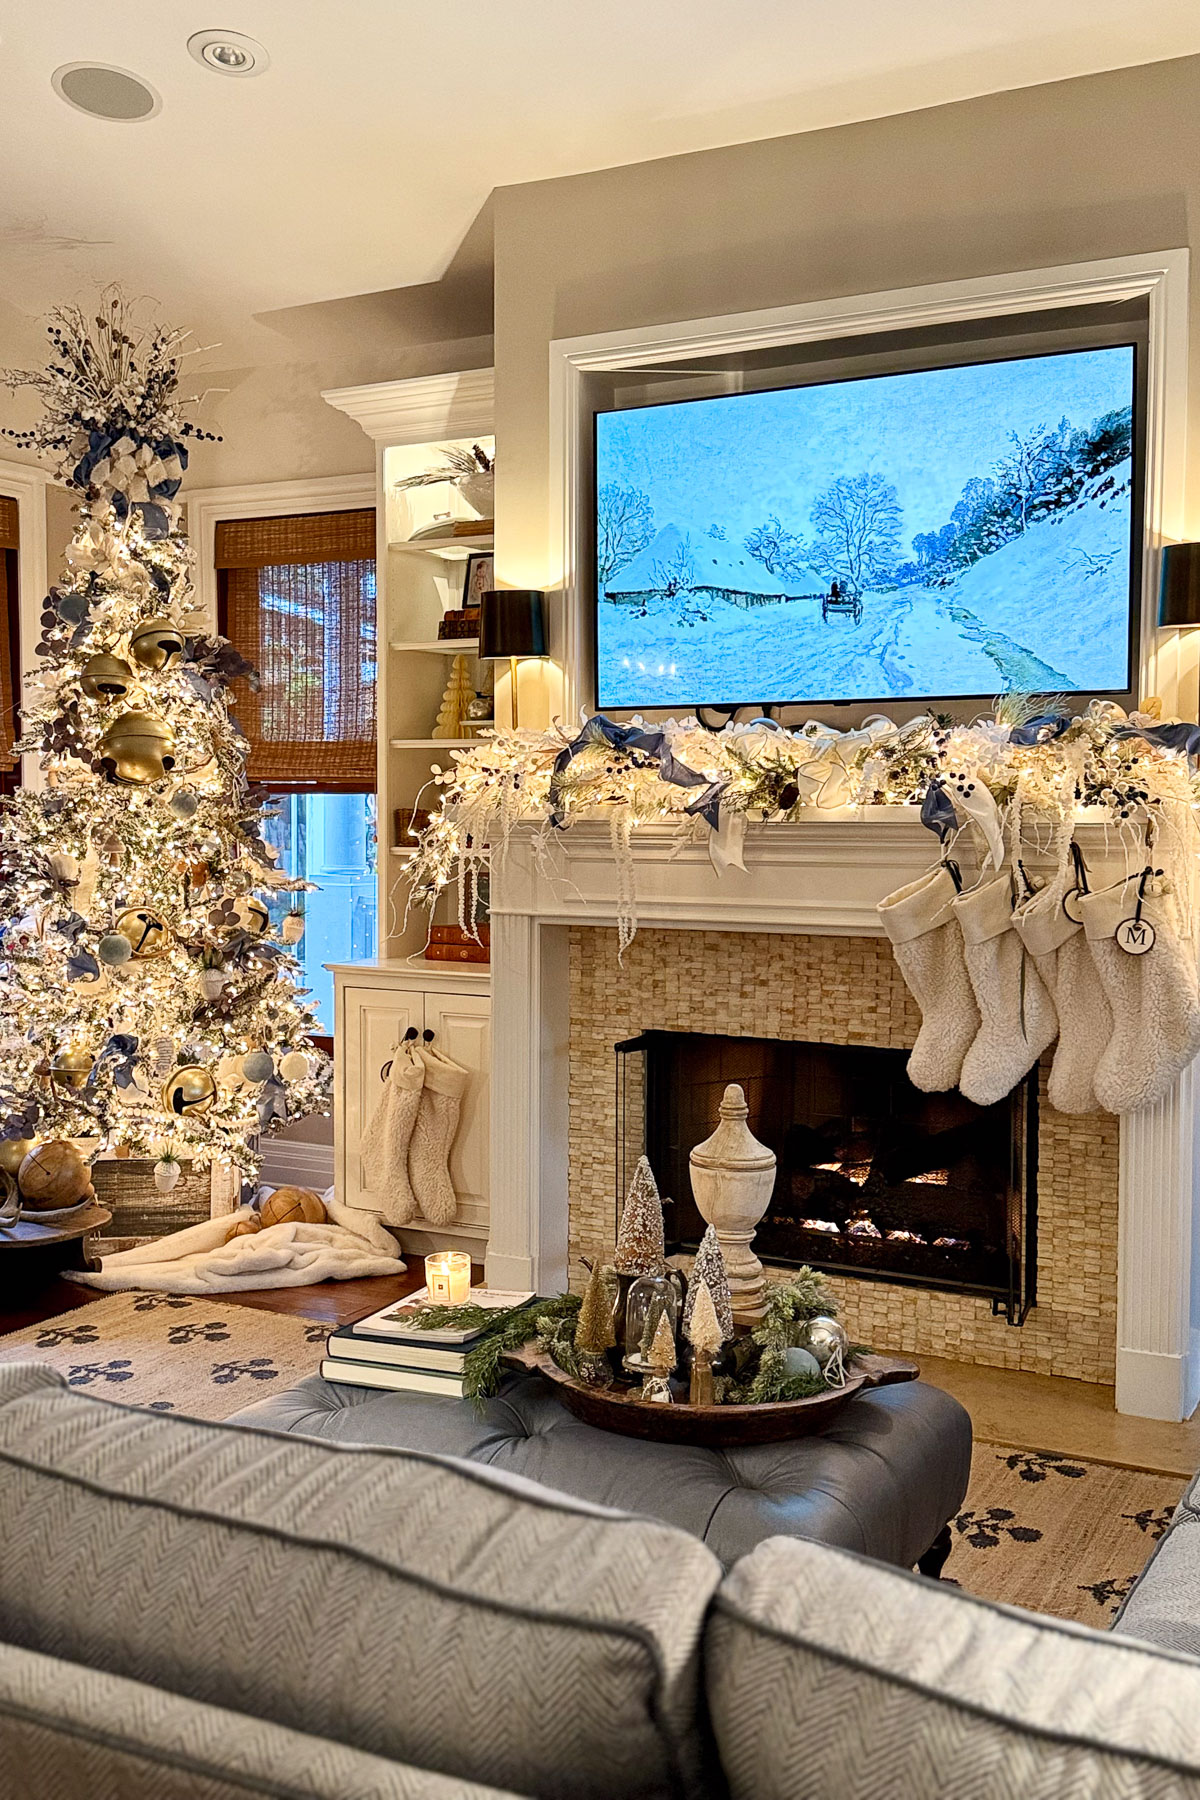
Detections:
[945, 1444, 1184, 1629]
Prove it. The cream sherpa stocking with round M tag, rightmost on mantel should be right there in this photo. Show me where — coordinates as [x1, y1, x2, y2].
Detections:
[1078, 873, 1200, 1112]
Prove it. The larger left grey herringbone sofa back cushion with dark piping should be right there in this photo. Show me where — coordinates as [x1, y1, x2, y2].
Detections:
[0, 1363, 720, 1800]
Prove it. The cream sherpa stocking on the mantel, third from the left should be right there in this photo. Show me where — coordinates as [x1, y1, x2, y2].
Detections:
[1013, 882, 1112, 1112]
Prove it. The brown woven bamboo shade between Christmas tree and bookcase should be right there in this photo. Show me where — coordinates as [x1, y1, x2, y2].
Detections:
[216, 509, 376, 790]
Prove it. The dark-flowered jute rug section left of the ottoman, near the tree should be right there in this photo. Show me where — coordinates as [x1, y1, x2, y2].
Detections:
[0, 1292, 329, 1418]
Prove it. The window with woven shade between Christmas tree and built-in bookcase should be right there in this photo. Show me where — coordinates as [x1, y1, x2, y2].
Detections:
[216, 509, 378, 1035]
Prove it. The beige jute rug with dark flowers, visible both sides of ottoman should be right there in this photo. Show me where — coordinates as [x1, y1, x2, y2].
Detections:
[0, 1294, 1184, 1627]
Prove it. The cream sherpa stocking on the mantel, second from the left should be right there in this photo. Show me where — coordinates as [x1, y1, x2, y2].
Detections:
[954, 871, 1058, 1107]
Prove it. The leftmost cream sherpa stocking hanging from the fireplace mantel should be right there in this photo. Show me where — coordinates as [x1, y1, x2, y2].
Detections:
[876, 868, 979, 1093]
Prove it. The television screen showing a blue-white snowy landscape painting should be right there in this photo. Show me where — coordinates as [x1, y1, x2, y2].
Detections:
[596, 346, 1133, 707]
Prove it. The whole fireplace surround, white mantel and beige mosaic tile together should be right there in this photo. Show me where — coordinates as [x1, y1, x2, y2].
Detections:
[488, 808, 1200, 1418]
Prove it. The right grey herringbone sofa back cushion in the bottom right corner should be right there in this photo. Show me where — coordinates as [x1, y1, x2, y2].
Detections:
[705, 1537, 1200, 1800]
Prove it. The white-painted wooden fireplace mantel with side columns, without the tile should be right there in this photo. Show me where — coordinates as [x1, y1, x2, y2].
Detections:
[488, 806, 1200, 1418]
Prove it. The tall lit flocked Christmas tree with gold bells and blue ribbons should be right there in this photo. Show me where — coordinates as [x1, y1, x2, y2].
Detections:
[0, 292, 329, 1177]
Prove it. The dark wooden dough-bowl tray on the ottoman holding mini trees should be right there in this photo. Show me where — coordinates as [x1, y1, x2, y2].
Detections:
[504, 1345, 921, 1449]
